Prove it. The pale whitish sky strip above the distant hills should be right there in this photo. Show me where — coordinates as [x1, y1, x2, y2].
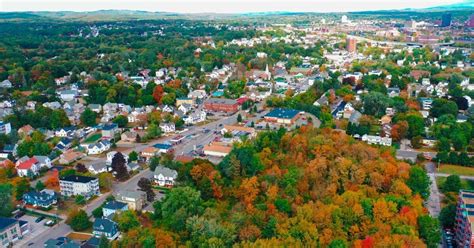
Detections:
[0, 0, 466, 13]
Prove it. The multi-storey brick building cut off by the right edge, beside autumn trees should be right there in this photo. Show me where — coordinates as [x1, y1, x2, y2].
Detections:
[454, 190, 474, 247]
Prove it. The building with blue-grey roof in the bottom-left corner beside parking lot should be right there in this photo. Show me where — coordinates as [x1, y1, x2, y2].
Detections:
[0, 217, 29, 247]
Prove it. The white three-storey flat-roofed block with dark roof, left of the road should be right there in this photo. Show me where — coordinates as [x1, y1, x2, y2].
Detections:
[59, 175, 100, 198]
